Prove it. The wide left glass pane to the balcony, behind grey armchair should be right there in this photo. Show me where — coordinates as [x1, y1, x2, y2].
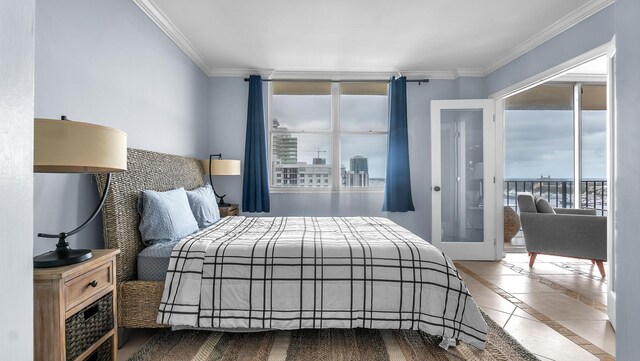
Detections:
[504, 84, 574, 209]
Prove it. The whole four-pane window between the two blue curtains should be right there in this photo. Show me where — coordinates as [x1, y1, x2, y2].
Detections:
[269, 82, 388, 191]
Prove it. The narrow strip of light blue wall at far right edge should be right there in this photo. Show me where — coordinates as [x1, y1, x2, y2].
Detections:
[615, 0, 640, 360]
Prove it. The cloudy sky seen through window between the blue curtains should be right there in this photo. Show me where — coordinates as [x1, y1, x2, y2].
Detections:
[272, 95, 388, 178]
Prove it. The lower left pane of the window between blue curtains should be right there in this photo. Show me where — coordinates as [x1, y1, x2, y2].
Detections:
[271, 133, 333, 188]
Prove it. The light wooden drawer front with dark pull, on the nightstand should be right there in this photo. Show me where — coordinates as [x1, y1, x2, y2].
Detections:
[64, 262, 113, 310]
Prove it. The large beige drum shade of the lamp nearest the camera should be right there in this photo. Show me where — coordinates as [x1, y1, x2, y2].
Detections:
[33, 119, 127, 173]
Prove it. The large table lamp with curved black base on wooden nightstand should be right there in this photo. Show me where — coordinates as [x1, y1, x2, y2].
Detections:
[33, 116, 127, 268]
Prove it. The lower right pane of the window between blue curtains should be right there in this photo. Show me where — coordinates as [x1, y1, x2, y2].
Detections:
[340, 134, 387, 187]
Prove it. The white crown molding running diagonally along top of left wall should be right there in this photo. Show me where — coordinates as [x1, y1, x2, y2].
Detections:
[133, 0, 211, 76]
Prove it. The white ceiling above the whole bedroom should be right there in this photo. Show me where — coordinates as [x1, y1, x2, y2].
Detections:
[134, 0, 613, 78]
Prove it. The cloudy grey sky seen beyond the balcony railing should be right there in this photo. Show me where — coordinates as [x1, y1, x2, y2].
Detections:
[504, 110, 606, 179]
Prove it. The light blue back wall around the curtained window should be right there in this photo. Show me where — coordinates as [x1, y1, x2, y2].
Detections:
[210, 78, 460, 239]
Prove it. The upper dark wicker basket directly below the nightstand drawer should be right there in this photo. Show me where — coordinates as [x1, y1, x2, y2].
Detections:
[65, 292, 113, 360]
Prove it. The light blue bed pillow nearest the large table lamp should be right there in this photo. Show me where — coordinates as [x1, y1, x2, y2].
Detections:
[138, 188, 198, 246]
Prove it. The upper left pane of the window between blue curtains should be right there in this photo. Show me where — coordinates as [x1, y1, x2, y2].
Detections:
[271, 82, 331, 130]
